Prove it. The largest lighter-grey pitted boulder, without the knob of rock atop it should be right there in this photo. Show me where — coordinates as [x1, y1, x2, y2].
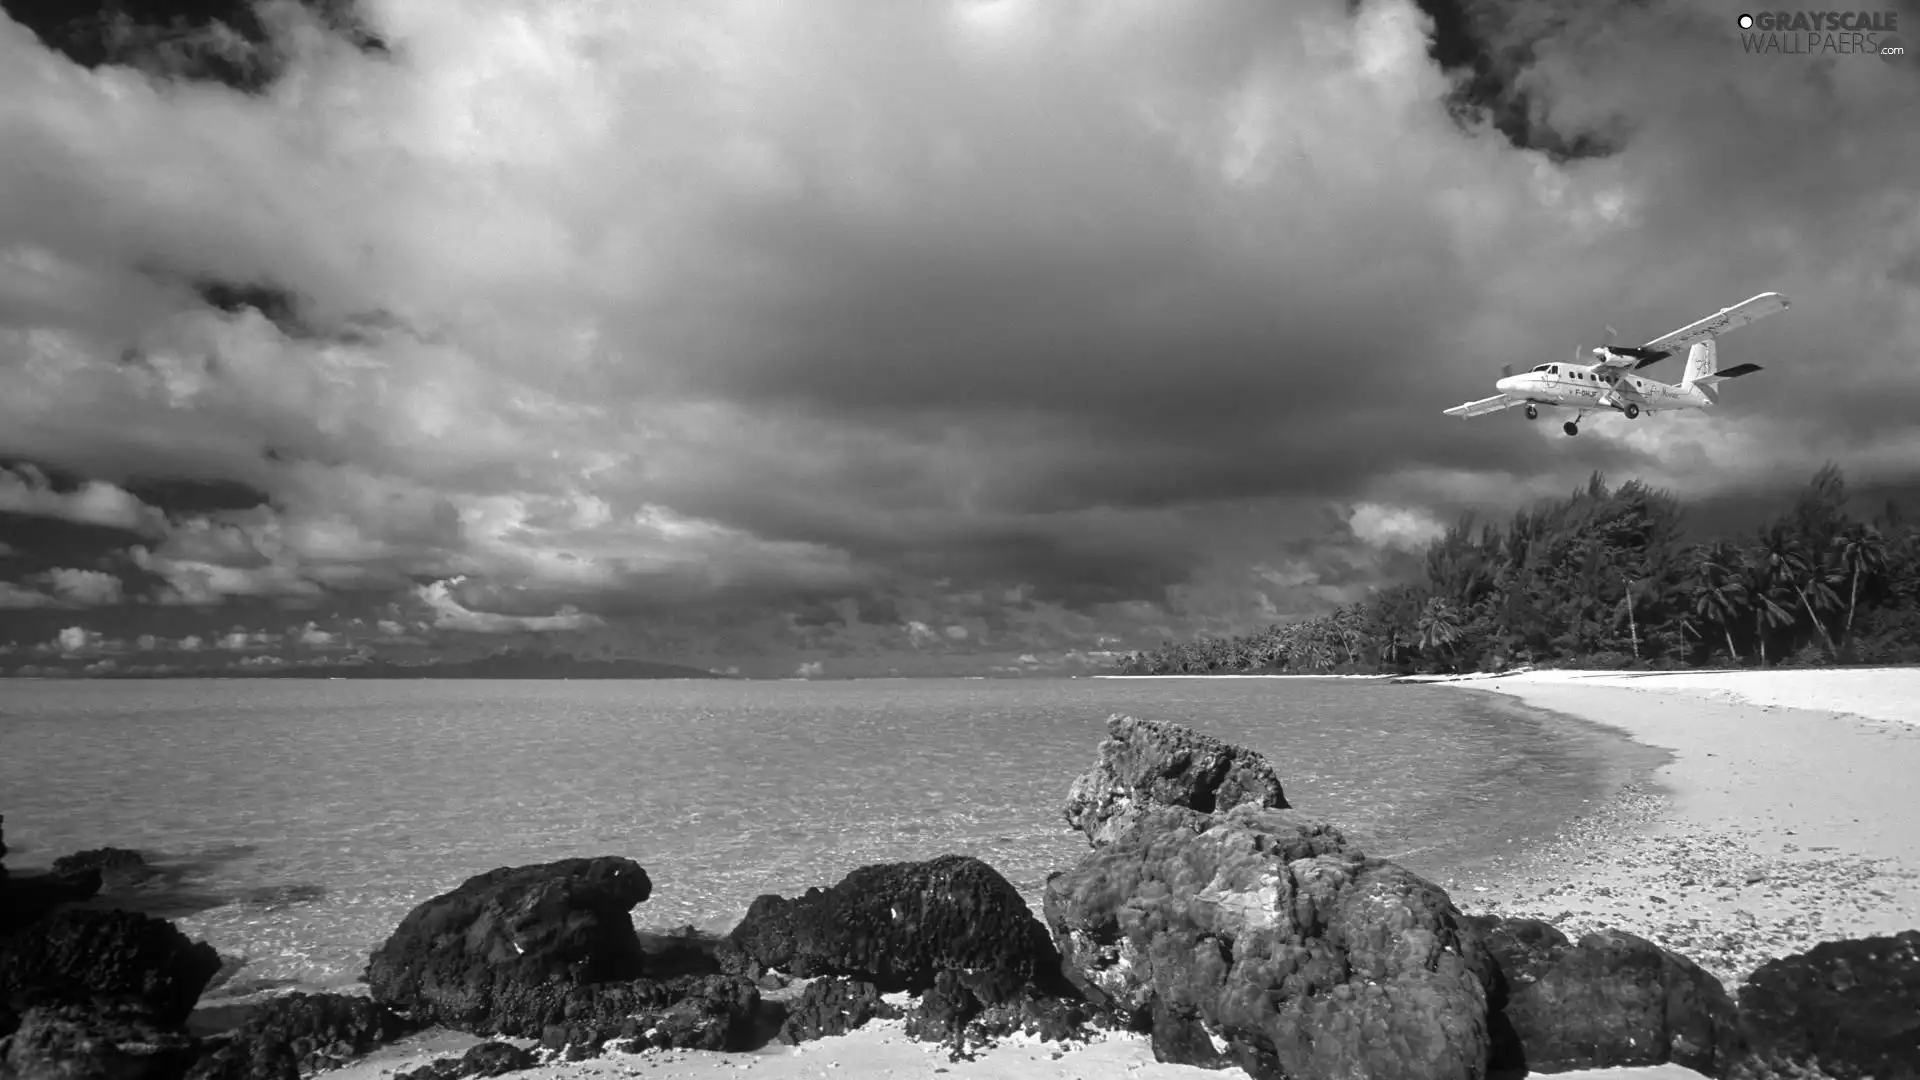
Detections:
[1046, 801, 1496, 1080]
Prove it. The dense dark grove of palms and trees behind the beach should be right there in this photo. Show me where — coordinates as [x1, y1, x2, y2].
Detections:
[1116, 465, 1920, 675]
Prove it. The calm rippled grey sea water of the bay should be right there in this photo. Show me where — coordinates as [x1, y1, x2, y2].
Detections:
[0, 678, 1644, 994]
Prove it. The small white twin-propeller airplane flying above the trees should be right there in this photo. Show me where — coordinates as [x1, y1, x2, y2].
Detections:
[1446, 292, 1788, 434]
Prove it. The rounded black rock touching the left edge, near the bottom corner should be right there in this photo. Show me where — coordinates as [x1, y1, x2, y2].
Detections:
[0, 911, 221, 1026]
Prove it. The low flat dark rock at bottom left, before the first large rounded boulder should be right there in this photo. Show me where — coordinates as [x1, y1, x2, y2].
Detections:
[185, 994, 420, 1080]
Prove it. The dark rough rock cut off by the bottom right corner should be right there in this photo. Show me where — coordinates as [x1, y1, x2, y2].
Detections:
[1728, 930, 1920, 1080]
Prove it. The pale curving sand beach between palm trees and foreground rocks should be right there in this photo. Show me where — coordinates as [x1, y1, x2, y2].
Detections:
[1446, 669, 1920, 992]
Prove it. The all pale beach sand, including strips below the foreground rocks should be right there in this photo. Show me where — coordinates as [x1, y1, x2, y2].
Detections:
[318, 669, 1920, 1080]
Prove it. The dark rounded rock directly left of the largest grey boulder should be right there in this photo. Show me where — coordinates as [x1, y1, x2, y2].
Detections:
[730, 855, 1060, 999]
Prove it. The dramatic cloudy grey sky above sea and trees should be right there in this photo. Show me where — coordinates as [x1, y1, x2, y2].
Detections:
[0, 0, 1920, 675]
